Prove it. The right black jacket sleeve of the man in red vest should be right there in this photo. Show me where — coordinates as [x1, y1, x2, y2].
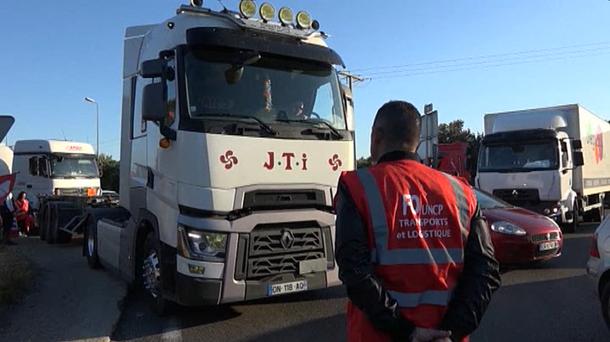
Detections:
[441, 208, 501, 341]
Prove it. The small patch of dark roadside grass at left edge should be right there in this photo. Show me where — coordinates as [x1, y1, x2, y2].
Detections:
[0, 245, 33, 307]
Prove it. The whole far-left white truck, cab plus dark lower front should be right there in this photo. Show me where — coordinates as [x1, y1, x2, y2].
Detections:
[13, 140, 101, 243]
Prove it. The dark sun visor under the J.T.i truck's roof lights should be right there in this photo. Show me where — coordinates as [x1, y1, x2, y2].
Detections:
[186, 27, 344, 66]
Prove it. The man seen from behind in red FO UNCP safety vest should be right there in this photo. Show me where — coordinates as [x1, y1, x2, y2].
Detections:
[335, 101, 500, 342]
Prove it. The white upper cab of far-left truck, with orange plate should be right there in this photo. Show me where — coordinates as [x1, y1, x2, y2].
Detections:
[13, 140, 101, 210]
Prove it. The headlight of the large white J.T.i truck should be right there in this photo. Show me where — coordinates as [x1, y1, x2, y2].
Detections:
[178, 226, 227, 261]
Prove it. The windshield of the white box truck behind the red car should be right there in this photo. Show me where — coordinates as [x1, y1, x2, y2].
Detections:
[479, 141, 558, 172]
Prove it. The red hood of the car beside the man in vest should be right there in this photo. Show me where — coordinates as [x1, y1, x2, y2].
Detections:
[482, 207, 559, 235]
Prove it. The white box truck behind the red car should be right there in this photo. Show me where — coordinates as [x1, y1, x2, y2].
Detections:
[476, 104, 610, 232]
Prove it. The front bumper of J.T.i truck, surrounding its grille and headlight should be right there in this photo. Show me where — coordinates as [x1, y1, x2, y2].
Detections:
[176, 210, 341, 306]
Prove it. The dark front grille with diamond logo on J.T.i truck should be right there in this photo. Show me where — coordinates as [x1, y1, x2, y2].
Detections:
[235, 225, 334, 280]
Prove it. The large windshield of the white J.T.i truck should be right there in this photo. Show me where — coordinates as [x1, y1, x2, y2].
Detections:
[184, 49, 346, 130]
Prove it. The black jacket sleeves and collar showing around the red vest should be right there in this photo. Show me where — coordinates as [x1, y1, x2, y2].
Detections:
[335, 152, 500, 341]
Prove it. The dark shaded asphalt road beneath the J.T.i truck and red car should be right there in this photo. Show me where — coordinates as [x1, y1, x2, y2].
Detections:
[112, 225, 610, 342]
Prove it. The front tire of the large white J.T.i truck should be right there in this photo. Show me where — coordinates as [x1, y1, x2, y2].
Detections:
[138, 232, 170, 316]
